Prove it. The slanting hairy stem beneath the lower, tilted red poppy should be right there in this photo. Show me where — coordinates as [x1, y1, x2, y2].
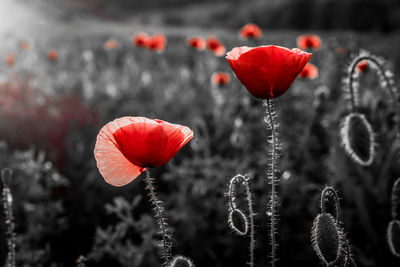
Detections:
[145, 168, 171, 265]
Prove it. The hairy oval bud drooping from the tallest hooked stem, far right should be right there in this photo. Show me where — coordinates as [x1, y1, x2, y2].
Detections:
[340, 113, 375, 166]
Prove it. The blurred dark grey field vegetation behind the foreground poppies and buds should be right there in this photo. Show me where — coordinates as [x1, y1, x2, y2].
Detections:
[0, 30, 400, 267]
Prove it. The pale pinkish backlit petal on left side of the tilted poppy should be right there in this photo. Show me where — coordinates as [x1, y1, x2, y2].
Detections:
[94, 118, 145, 186]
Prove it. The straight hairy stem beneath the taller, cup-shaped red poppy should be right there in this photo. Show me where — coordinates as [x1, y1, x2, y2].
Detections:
[264, 99, 278, 267]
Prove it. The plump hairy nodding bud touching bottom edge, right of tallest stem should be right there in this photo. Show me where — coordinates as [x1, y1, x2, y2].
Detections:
[311, 213, 344, 265]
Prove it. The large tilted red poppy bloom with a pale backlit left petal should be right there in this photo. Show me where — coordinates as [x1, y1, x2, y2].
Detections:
[94, 117, 193, 186]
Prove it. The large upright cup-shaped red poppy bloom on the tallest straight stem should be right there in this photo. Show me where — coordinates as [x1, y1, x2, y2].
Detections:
[225, 45, 311, 98]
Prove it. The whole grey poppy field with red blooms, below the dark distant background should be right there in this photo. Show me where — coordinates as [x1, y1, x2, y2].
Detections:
[0, 23, 400, 267]
